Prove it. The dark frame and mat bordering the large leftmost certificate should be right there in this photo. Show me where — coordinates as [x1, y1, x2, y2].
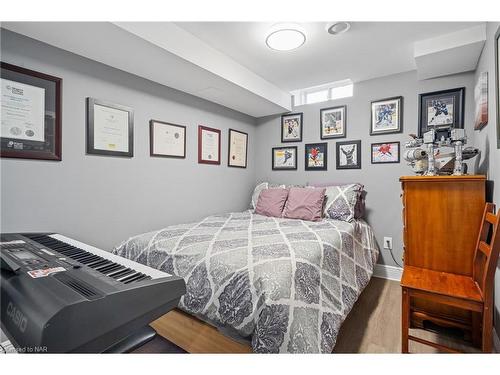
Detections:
[0, 62, 62, 161]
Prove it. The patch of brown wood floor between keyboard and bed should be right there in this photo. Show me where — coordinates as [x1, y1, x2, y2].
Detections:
[147, 309, 252, 353]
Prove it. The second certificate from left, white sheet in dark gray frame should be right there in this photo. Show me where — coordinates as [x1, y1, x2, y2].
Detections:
[87, 98, 134, 158]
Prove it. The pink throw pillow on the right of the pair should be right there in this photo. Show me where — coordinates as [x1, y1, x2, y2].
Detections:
[283, 188, 326, 221]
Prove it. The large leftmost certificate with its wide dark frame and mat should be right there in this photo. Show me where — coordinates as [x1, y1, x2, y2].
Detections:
[0, 62, 62, 160]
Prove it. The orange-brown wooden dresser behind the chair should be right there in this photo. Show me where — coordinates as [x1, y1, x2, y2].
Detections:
[400, 176, 486, 328]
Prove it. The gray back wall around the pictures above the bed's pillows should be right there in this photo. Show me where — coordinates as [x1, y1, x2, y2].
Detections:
[255, 68, 474, 265]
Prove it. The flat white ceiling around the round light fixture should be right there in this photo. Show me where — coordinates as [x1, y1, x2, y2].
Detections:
[177, 22, 481, 91]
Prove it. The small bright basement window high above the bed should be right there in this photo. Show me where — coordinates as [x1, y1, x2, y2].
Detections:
[291, 79, 354, 106]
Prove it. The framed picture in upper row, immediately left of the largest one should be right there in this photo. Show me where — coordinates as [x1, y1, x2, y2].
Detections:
[370, 96, 403, 135]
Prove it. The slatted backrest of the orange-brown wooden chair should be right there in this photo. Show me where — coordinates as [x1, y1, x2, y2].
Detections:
[473, 203, 500, 301]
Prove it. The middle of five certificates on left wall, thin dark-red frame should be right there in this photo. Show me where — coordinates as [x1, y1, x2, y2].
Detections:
[149, 120, 186, 158]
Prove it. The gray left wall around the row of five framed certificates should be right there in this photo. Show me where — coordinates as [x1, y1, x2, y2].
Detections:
[0, 30, 255, 253]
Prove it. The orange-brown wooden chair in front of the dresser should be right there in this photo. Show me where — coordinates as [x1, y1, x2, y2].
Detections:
[401, 203, 500, 353]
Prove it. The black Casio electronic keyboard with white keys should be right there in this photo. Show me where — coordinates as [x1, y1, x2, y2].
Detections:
[0, 233, 186, 353]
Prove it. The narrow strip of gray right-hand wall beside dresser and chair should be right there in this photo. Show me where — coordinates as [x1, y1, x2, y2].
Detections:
[474, 22, 500, 336]
